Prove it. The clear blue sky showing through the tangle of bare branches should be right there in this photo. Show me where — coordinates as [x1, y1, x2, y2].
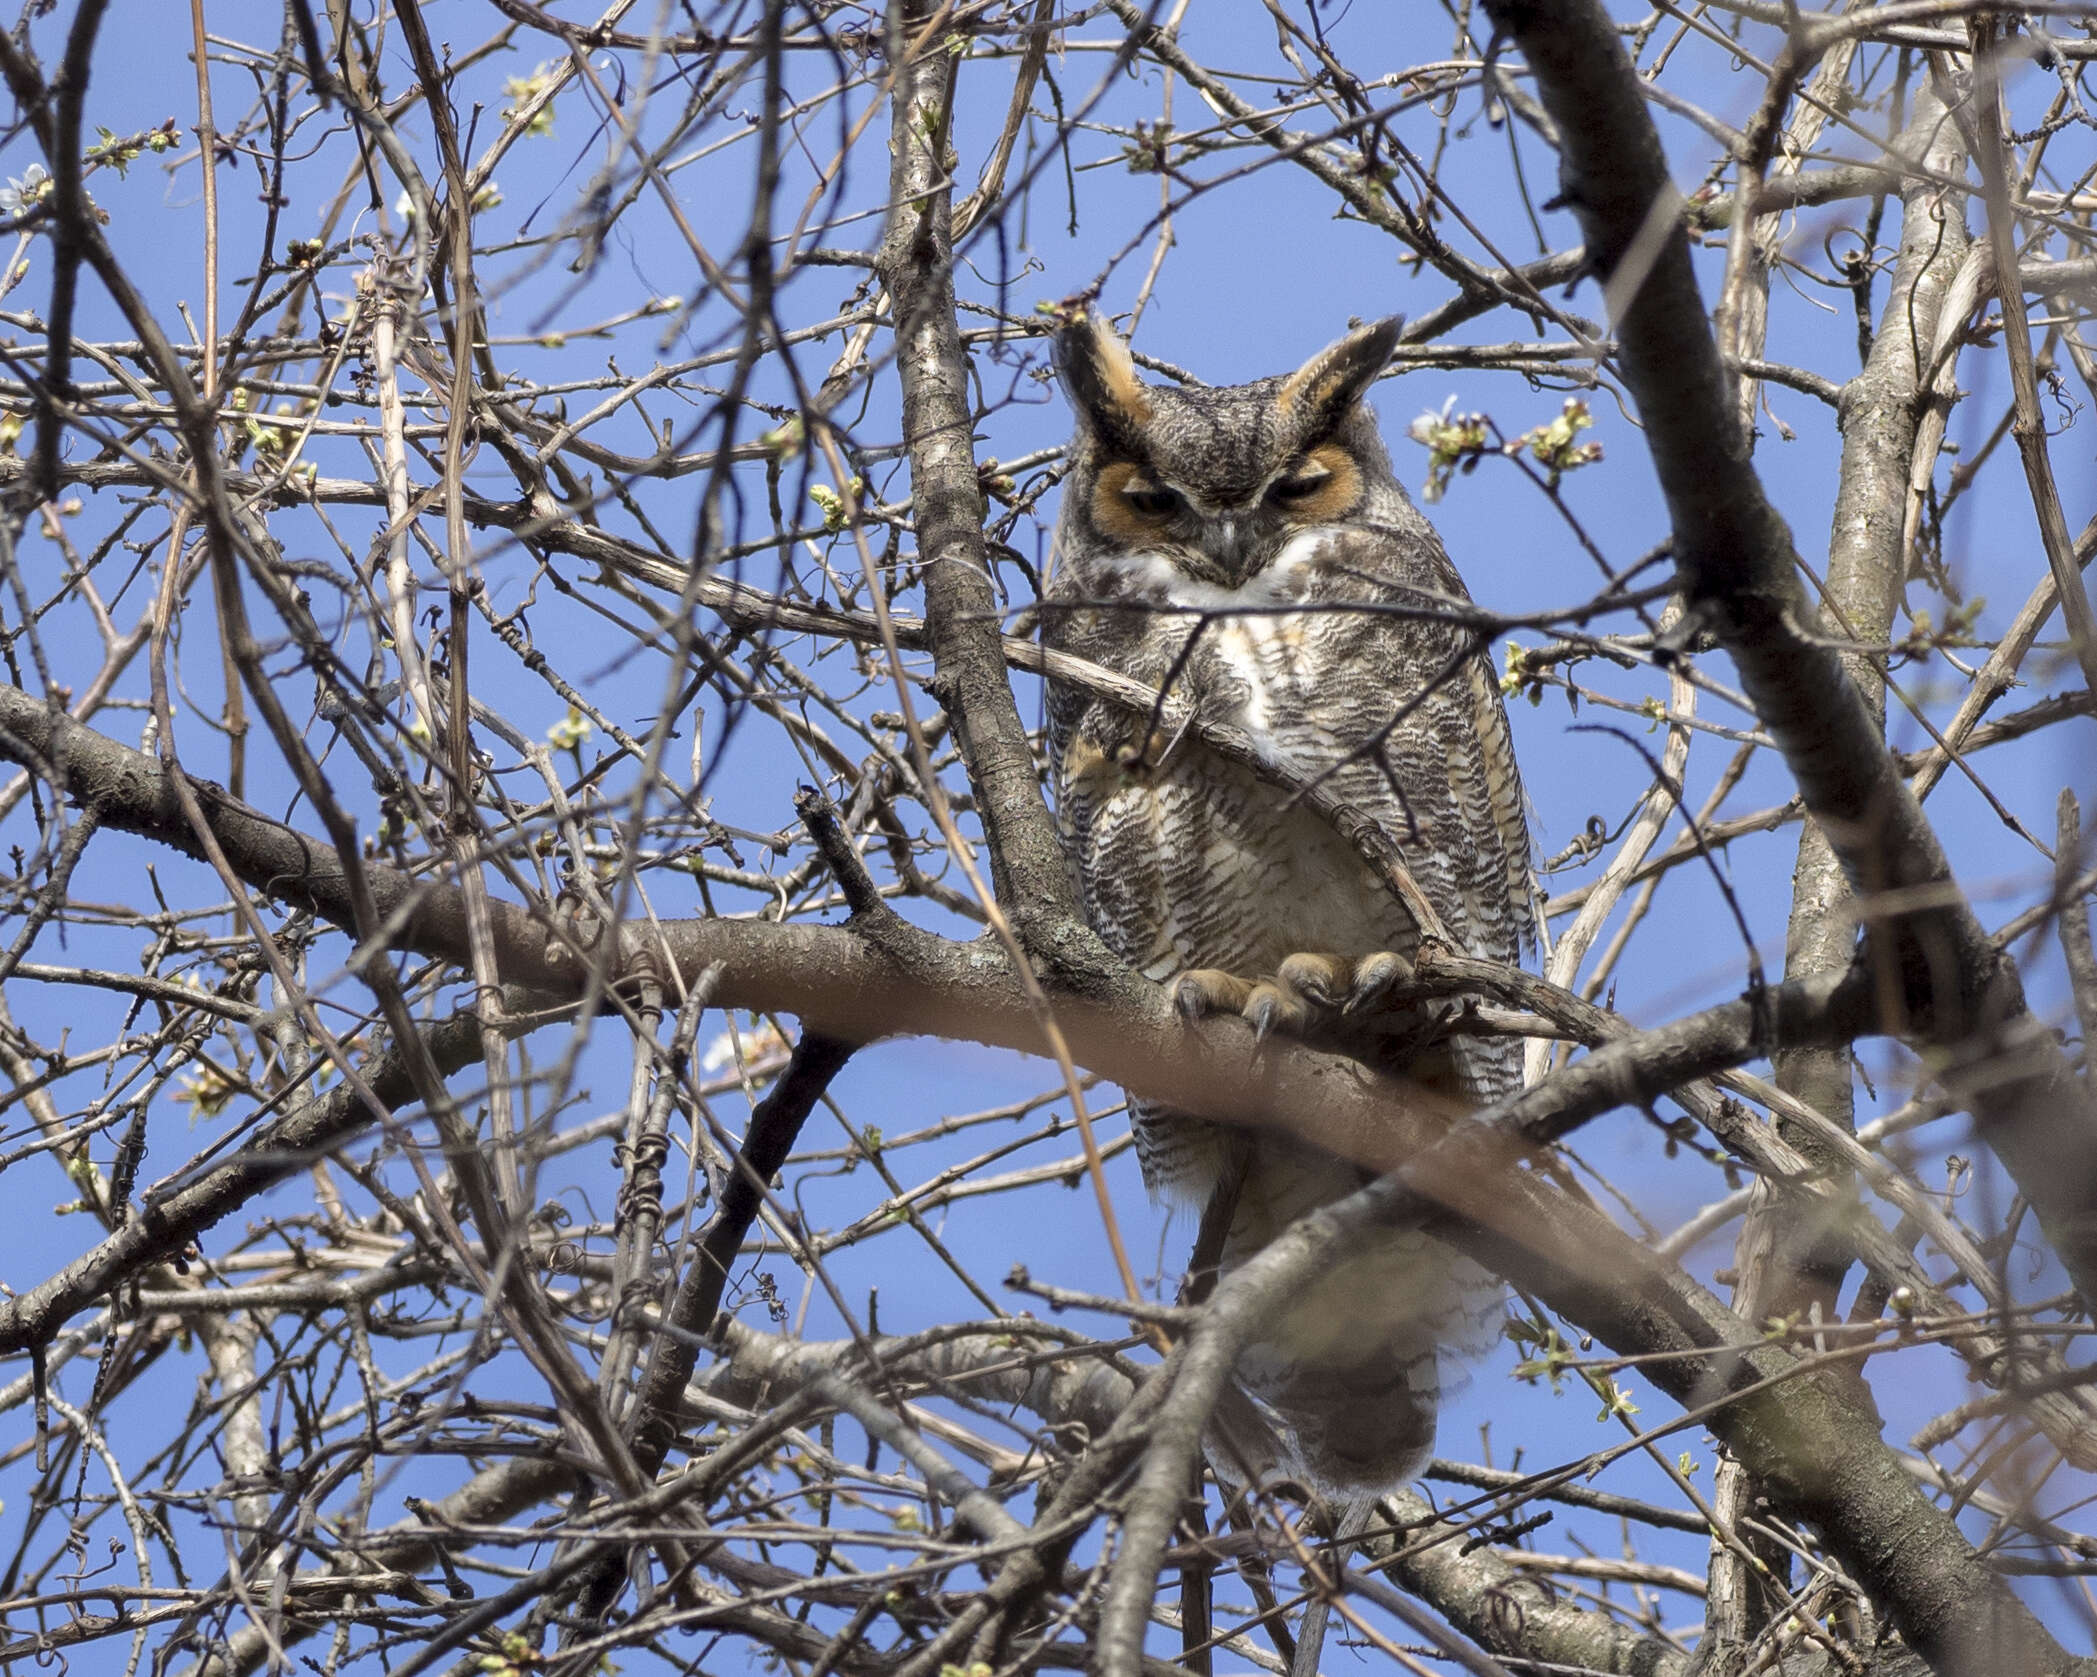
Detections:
[0, 0, 2097, 1660]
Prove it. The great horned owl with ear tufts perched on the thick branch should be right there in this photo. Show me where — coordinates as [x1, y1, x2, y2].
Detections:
[1042, 314, 1531, 1497]
